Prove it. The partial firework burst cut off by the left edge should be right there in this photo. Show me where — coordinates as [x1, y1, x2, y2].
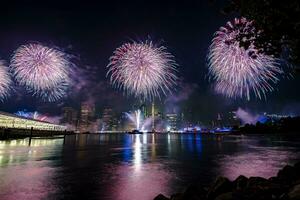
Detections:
[0, 60, 12, 101]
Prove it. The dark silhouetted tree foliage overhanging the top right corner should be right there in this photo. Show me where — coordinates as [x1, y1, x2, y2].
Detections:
[223, 0, 300, 67]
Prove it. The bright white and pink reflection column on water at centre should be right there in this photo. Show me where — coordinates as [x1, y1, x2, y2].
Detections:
[108, 135, 172, 200]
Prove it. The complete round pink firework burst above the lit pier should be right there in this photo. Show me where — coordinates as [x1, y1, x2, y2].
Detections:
[10, 43, 70, 101]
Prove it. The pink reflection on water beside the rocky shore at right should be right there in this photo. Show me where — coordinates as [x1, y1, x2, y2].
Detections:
[216, 145, 299, 180]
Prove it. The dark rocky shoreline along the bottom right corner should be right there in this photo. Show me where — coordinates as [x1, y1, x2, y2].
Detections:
[154, 162, 300, 200]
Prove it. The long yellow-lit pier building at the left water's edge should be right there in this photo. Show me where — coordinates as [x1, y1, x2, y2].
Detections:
[0, 112, 66, 131]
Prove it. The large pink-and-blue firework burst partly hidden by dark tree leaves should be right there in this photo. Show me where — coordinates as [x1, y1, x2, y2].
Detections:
[208, 18, 283, 100]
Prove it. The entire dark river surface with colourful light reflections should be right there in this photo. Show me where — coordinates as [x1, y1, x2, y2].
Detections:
[0, 134, 300, 200]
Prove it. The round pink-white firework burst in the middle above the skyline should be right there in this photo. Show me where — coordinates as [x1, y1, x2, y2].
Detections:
[107, 41, 177, 100]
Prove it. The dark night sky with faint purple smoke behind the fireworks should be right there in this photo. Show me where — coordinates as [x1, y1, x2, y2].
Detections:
[0, 0, 300, 121]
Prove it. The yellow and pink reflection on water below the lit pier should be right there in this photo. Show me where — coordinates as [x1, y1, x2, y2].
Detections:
[0, 139, 63, 200]
